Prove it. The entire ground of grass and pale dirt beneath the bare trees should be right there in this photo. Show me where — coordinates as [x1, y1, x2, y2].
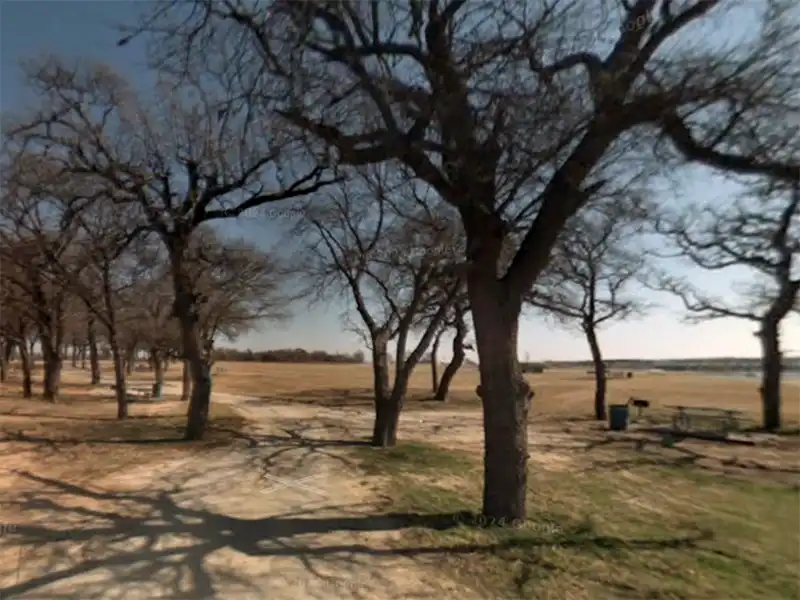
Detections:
[0, 363, 800, 600]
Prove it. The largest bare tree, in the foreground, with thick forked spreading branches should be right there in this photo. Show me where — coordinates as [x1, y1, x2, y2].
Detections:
[128, 0, 798, 519]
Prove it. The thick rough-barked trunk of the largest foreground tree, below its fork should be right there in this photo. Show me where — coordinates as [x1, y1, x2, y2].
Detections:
[468, 278, 532, 523]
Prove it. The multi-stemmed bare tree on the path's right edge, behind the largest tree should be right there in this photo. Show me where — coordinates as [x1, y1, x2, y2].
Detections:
[297, 172, 463, 446]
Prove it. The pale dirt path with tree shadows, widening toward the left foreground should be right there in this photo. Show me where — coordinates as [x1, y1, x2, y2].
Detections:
[0, 394, 478, 600]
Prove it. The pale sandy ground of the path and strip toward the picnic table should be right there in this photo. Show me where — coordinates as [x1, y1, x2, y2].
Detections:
[0, 370, 800, 600]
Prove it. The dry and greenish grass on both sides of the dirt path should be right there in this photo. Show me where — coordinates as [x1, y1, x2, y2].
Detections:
[0, 363, 800, 600]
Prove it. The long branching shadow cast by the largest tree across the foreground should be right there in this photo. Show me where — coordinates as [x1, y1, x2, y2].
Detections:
[0, 472, 707, 600]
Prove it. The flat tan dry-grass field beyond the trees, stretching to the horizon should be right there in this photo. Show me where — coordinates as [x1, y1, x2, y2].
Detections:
[203, 363, 800, 423]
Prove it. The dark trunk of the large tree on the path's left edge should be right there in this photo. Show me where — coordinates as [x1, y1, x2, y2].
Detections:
[171, 245, 211, 440]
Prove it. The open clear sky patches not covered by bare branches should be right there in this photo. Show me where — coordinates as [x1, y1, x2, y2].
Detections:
[0, 0, 800, 360]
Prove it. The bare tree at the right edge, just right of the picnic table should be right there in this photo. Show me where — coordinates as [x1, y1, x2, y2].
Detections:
[658, 179, 800, 430]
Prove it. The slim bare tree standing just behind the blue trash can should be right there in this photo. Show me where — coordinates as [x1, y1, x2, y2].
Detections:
[526, 205, 647, 420]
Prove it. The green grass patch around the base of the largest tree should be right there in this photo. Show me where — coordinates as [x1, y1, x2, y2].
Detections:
[357, 443, 800, 600]
